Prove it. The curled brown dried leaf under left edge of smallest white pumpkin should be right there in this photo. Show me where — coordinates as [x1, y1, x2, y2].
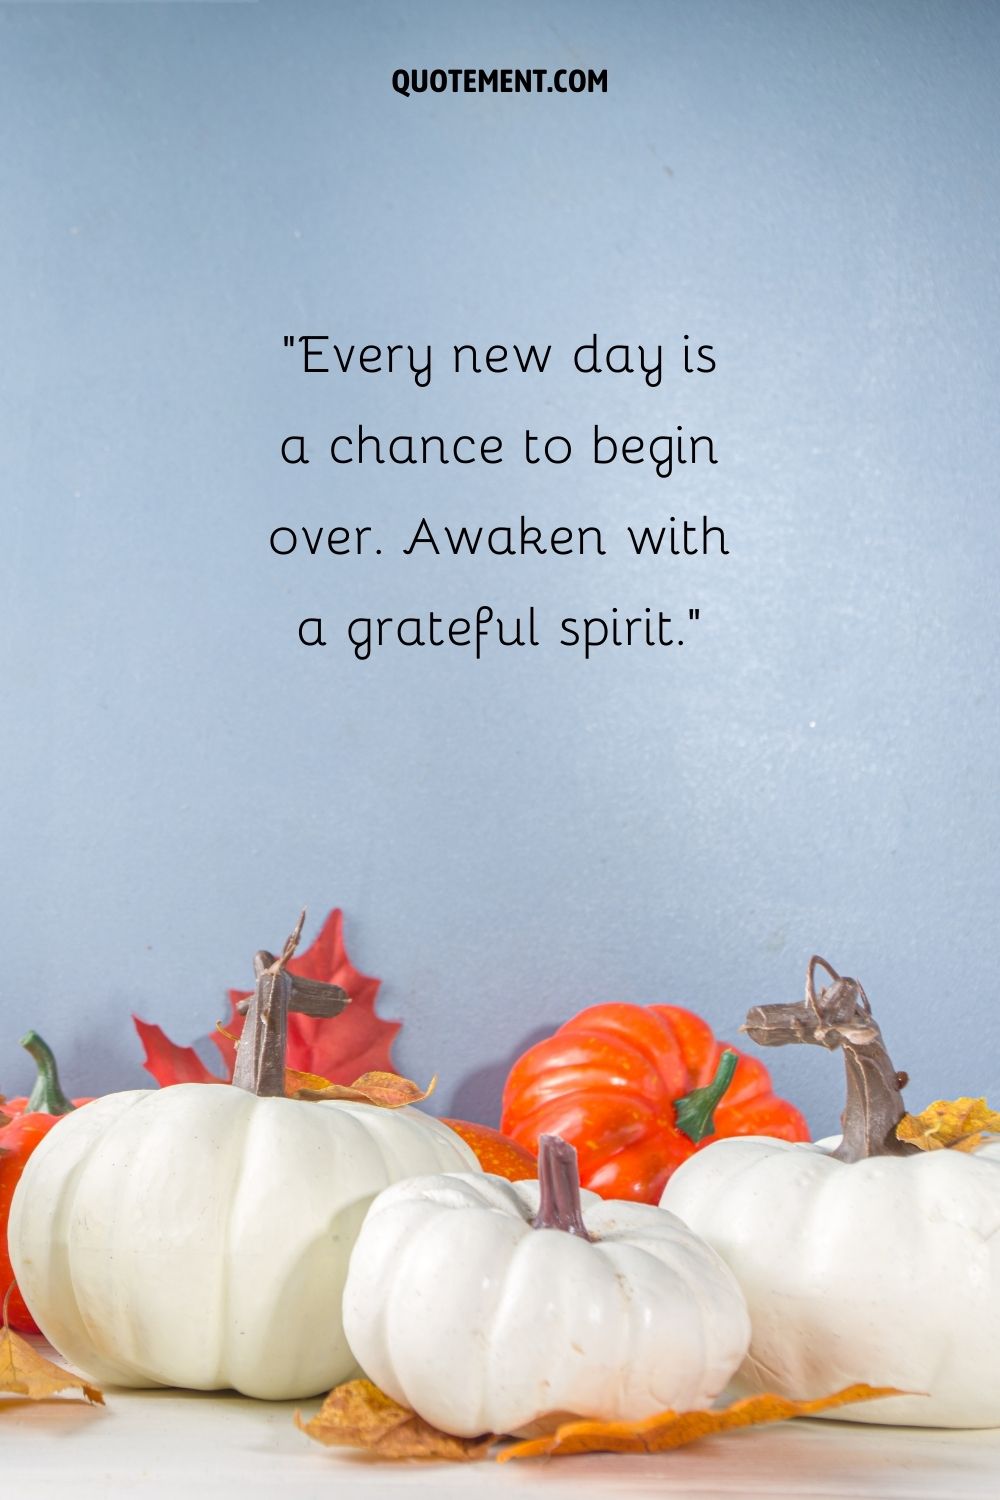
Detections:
[295, 1380, 495, 1463]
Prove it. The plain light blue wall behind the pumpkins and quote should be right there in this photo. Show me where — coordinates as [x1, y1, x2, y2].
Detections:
[0, 0, 1000, 1130]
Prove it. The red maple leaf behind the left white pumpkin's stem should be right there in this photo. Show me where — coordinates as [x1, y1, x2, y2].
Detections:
[132, 909, 400, 1086]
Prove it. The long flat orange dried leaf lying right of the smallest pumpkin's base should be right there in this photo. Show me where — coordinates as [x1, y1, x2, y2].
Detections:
[496, 1385, 903, 1463]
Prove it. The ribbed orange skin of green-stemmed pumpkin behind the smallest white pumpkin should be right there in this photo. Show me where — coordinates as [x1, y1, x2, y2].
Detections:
[501, 1004, 810, 1203]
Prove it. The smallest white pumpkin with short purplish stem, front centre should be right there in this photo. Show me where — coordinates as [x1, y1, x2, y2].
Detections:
[343, 1136, 750, 1437]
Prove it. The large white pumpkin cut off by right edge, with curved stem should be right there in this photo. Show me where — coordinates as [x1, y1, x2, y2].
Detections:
[661, 959, 1000, 1427]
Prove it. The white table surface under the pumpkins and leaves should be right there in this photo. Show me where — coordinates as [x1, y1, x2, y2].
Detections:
[7, 1350, 1000, 1500]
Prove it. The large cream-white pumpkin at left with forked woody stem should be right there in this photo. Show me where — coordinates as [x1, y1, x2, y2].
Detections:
[9, 918, 477, 1401]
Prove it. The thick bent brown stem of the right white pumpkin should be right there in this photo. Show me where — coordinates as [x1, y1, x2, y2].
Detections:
[744, 954, 918, 1161]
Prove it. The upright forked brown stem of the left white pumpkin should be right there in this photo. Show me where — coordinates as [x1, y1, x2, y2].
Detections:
[232, 912, 349, 1098]
